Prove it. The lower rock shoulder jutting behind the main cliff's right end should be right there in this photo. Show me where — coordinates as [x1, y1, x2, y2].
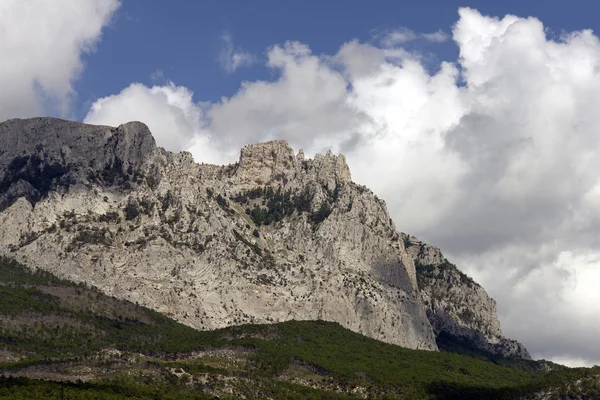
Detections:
[402, 234, 531, 359]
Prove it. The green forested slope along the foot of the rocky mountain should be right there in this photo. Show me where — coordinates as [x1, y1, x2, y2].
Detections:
[0, 258, 599, 399]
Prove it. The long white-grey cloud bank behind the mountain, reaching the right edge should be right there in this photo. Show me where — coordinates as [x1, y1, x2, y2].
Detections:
[82, 8, 600, 364]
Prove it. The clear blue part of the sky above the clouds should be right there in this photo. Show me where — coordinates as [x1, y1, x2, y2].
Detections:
[74, 0, 600, 119]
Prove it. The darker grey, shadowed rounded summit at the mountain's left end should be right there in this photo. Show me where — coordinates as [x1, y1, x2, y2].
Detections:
[0, 118, 156, 211]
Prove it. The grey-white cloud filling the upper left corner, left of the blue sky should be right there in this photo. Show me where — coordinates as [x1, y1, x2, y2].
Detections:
[0, 0, 119, 120]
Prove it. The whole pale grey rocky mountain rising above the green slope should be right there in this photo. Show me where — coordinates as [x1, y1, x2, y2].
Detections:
[0, 118, 529, 358]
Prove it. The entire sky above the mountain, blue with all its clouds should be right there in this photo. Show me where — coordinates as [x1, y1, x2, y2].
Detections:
[0, 0, 600, 366]
